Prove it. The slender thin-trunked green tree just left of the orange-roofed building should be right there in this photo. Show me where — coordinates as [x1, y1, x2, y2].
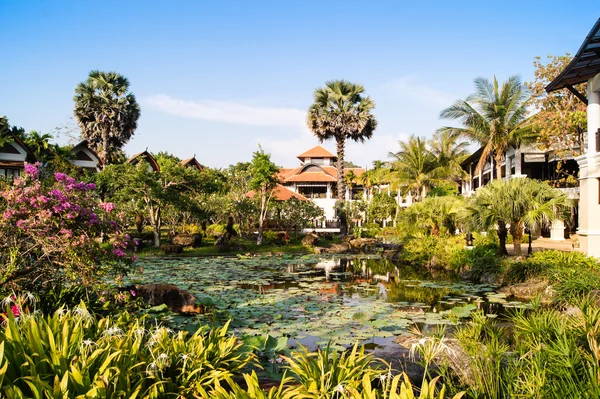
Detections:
[250, 148, 279, 245]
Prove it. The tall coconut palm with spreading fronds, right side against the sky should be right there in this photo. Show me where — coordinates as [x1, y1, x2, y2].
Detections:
[439, 76, 533, 177]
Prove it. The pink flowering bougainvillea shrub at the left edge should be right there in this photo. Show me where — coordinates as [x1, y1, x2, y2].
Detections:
[0, 165, 132, 289]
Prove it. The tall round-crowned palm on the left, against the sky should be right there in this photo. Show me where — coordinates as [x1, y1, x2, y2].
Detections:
[73, 70, 140, 165]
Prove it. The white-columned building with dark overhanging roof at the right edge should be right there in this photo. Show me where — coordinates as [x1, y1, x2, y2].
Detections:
[546, 19, 600, 257]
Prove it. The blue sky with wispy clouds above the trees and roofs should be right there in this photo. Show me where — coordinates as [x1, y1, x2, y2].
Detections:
[0, 0, 600, 167]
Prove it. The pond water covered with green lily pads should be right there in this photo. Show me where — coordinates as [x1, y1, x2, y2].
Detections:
[127, 255, 524, 349]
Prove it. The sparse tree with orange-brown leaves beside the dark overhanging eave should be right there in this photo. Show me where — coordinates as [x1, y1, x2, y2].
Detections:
[526, 53, 587, 156]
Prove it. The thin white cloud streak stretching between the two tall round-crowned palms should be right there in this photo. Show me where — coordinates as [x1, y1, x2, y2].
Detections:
[143, 94, 306, 127]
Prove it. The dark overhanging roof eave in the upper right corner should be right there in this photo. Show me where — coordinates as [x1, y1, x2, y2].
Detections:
[546, 18, 600, 93]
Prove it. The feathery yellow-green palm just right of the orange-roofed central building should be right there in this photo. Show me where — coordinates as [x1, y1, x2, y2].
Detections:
[387, 136, 442, 201]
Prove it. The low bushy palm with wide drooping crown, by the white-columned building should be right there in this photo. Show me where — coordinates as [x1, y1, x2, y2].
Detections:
[469, 178, 572, 255]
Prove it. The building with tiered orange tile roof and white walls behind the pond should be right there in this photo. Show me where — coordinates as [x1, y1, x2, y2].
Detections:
[279, 145, 365, 223]
